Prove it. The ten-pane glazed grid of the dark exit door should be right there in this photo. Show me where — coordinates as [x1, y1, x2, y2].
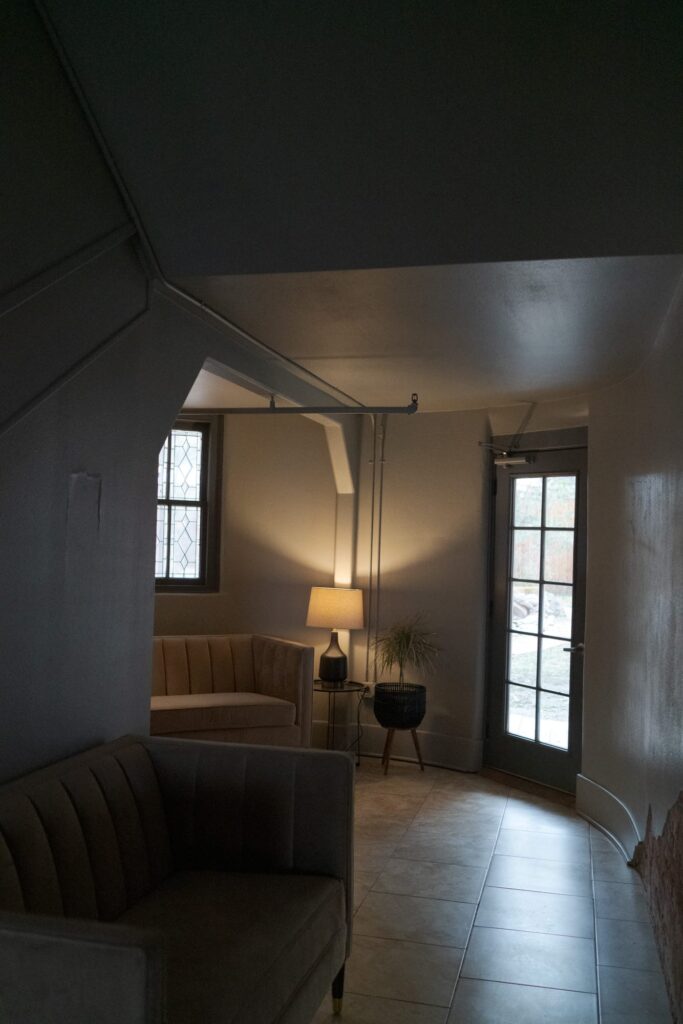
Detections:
[505, 473, 578, 751]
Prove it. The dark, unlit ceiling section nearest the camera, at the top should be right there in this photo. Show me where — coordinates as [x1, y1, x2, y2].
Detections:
[42, 0, 683, 276]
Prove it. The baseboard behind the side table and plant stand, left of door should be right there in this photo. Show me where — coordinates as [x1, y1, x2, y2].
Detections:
[313, 720, 483, 772]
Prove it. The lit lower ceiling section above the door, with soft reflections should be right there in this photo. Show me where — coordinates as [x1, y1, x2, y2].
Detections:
[181, 256, 683, 412]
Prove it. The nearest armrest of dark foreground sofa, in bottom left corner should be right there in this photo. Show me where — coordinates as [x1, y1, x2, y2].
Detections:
[0, 913, 165, 1024]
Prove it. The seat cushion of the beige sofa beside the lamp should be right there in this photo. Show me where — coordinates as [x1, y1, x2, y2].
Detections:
[152, 691, 296, 735]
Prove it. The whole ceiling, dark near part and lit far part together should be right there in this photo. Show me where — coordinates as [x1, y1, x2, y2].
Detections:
[43, 0, 683, 409]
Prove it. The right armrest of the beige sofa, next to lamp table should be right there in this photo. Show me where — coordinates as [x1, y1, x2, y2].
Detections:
[252, 634, 313, 746]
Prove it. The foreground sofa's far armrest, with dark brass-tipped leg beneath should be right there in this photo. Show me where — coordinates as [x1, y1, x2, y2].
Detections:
[146, 736, 355, 938]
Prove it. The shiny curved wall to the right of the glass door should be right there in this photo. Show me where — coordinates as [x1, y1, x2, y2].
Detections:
[578, 276, 683, 853]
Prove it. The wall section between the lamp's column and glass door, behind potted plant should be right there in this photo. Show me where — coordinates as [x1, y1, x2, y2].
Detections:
[354, 411, 488, 770]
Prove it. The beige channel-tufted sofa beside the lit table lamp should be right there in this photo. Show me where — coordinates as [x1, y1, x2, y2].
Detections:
[151, 634, 313, 746]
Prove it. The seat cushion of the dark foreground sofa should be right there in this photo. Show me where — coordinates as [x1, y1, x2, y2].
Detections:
[120, 870, 346, 1024]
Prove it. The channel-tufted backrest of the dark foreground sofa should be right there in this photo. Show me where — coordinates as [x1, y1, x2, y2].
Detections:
[0, 743, 173, 921]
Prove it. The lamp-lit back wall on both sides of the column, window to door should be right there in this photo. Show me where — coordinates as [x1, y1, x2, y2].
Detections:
[155, 412, 488, 770]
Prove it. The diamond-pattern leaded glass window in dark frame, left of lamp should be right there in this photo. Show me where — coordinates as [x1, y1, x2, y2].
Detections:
[155, 422, 218, 587]
